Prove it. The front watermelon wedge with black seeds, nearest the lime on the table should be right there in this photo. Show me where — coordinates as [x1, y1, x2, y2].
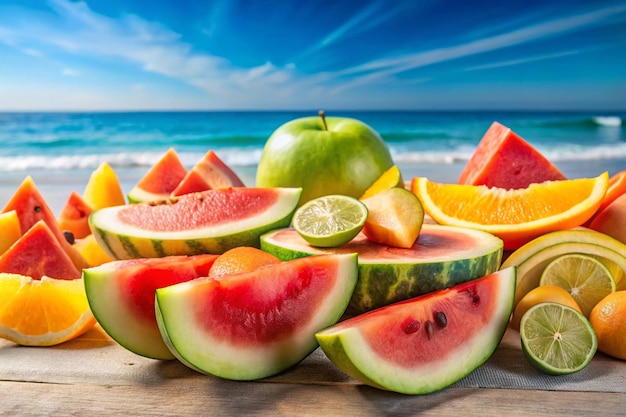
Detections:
[316, 268, 516, 394]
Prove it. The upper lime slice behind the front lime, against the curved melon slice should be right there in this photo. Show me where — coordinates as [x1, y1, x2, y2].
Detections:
[539, 253, 615, 317]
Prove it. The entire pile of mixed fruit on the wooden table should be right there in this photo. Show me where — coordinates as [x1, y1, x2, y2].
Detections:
[0, 114, 626, 394]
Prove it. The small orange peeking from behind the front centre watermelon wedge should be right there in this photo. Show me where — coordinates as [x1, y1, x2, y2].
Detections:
[209, 246, 280, 278]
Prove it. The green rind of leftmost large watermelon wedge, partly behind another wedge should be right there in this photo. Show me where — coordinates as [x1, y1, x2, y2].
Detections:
[83, 262, 175, 360]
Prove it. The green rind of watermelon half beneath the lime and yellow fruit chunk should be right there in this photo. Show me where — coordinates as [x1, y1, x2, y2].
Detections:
[261, 224, 503, 313]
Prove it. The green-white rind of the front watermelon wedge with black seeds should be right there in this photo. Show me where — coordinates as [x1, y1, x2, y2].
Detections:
[316, 267, 517, 395]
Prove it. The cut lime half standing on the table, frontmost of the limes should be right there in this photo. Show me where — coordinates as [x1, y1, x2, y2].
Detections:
[520, 302, 598, 375]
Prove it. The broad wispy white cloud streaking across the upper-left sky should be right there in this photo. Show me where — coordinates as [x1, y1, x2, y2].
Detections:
[0, 0, 295, 107]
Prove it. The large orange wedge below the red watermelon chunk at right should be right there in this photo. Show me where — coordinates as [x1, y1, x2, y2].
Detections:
[411, 172, 608, 250]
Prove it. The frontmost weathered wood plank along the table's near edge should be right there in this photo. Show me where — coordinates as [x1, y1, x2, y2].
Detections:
[0, 380, 626, 417]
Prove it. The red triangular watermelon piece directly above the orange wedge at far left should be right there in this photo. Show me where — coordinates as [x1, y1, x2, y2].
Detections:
[0, 220, 82, 280]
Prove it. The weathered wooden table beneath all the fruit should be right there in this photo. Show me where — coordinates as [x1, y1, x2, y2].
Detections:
[0, 327, 626, 417]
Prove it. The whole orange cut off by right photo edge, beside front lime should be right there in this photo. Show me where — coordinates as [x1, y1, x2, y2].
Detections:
[589, 290, 626, 360]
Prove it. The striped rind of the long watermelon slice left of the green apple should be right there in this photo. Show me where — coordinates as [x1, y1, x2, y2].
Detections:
[89, 188, 302, 259]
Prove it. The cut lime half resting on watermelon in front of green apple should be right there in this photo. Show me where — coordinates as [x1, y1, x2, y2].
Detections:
[292, 195, 368, 248]
